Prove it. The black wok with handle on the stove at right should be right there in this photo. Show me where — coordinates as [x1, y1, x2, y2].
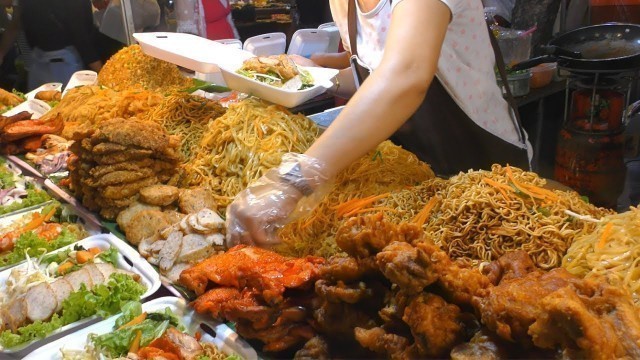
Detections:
[511, 23, 640, 72]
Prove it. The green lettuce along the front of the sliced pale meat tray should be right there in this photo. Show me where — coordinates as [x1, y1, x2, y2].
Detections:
[0, 274, 145, 348]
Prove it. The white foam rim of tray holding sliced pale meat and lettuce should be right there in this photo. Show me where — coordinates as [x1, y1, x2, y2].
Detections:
[0, 234, 160, 359]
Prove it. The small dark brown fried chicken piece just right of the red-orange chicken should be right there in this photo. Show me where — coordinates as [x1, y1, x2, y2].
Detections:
[320, 255, 380, 282]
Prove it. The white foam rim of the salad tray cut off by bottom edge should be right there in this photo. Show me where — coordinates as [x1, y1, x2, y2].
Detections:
[24, 297, 258, 360]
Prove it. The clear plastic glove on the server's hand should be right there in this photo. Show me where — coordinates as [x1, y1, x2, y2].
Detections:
[226, 153, 330, 247]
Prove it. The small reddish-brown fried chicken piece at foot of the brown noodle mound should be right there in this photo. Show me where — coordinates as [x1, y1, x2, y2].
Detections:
[482, 250, 538, 285]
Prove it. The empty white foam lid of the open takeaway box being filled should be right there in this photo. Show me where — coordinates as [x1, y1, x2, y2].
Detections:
[133, 32, 254, 73]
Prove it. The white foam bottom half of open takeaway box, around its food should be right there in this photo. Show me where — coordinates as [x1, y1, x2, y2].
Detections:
[220, 59, 338, 108]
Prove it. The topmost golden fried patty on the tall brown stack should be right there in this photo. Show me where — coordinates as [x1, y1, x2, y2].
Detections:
[91, 118, 170, 152]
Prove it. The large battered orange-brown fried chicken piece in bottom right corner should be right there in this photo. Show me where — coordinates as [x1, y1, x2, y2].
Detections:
[473, 255, 640, 359]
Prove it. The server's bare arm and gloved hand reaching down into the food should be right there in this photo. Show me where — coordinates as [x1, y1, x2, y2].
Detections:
[227, 0, 451, 245]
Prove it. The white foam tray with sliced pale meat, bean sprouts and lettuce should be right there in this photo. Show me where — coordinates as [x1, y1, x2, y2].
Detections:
[0, 234, 160, 354]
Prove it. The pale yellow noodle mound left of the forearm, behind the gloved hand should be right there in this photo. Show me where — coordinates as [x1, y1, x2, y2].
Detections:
[180, 98, 318, 208]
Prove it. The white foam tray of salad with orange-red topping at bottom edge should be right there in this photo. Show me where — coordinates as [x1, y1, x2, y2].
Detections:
[24, 297, 258, 360]
